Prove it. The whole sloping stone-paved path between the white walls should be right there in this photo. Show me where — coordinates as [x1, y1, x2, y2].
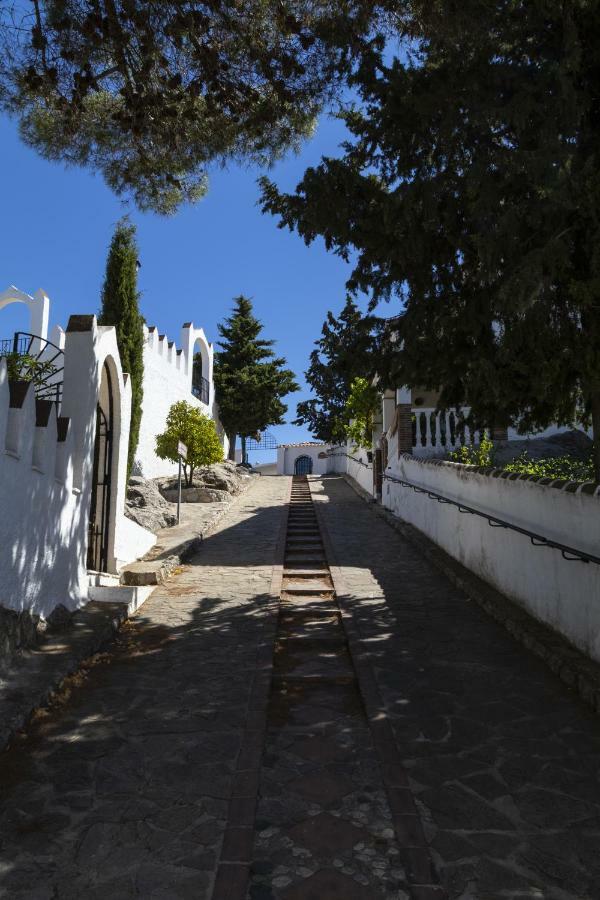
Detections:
[0, 477, 600, 900]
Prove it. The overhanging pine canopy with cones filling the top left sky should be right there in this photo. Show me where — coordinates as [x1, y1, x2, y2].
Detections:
[0, 0, 380, 213]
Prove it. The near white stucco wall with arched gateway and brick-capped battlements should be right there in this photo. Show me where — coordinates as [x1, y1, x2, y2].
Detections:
[0, 316, 155, 616]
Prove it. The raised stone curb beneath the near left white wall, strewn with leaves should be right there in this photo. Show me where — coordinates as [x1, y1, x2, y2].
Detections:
[0, 602, 128, 751]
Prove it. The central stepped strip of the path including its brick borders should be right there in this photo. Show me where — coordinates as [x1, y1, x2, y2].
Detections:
[213, 476, 446, 900]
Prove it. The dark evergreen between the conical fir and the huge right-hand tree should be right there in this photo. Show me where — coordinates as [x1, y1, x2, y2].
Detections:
[294, 297, 378, 443]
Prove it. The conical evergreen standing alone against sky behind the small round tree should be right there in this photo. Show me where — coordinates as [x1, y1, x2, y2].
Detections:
[213, 296, 298, 459]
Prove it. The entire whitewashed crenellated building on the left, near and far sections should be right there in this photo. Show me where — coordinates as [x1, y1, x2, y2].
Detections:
[0, 287, 222, 640]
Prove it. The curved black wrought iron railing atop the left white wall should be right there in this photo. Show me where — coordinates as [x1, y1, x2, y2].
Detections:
[0, 331, 64, 404]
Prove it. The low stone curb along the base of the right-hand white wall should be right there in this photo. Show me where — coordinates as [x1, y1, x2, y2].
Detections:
[342, 475, 600, 713]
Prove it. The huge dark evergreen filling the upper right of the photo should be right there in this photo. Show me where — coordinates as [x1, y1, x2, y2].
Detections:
[263, 0, 600, 480]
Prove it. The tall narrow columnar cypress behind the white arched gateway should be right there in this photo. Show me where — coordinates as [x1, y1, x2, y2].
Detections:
[98, 218, 144, 477]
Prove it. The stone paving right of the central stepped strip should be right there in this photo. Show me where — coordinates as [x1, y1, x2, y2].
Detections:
[311, 477, 600, 900]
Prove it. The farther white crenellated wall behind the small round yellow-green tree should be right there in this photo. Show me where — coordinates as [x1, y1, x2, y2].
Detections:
[136, 323, 228, 478]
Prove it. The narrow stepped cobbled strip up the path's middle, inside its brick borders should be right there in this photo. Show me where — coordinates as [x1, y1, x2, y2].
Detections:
[248, 479, 409, 900]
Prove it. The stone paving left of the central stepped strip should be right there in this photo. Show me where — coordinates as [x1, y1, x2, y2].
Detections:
[0, 478, 289, 900]
